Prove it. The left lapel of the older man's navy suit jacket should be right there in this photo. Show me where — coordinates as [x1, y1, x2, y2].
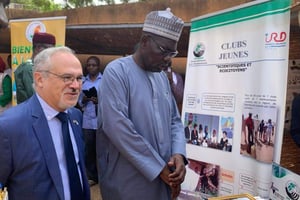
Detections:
[29, 95, 64, 199]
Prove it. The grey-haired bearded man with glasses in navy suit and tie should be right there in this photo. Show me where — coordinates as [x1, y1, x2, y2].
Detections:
[0, 47, 90, 200]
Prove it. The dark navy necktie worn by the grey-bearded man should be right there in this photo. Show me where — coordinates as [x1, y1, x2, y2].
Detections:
[56, 112, 84, 200]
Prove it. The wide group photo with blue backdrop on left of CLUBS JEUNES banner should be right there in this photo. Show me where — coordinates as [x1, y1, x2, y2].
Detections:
[184, 113, 234, 152]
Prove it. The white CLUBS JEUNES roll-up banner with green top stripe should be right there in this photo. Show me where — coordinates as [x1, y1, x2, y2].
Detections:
[180, 0, 291, 199]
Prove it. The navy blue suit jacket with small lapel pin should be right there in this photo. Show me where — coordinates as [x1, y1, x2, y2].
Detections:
[0, 95, 90, 200]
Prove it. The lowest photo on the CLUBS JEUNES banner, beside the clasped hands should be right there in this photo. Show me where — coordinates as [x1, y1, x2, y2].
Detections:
[178, 159, 220, 199]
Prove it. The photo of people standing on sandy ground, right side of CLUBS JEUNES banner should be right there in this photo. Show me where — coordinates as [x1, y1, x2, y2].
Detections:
[240, 105, 277, 163]
